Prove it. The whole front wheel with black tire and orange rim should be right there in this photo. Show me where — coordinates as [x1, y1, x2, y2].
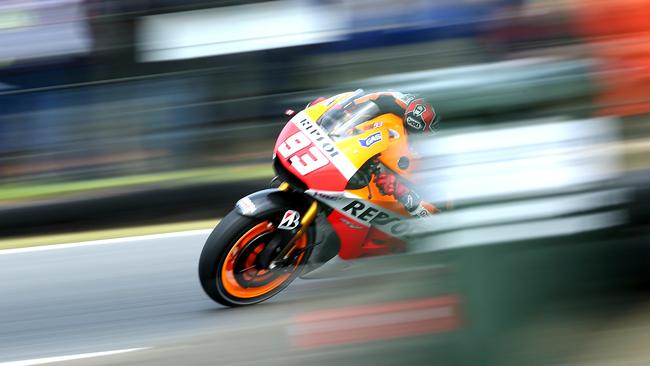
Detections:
[199, 212, 309, 306]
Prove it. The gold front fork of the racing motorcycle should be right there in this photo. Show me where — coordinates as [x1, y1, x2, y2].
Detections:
[257, 182, 318, 269]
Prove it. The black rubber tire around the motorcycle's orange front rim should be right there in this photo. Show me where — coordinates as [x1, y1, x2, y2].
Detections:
[199, 211, 313, 307]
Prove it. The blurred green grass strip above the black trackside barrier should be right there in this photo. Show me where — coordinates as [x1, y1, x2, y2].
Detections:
[0, 164, 273, 205]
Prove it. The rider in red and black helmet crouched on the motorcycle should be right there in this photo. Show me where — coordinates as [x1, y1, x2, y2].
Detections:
[309, 91, 440, 217]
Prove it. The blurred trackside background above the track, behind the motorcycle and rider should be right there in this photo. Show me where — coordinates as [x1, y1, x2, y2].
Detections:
[0, 0, 650, 234]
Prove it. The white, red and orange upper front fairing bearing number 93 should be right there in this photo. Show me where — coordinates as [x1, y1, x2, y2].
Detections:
[275, 93, 410, 201]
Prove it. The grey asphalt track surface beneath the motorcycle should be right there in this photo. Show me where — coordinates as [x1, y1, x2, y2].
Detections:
[0, 231, 450, 366]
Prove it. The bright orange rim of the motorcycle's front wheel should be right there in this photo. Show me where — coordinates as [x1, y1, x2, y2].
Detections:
[221, 221, 307, 299]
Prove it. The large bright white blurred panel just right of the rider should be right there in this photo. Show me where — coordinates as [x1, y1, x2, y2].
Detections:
[412, 119, 622, 203]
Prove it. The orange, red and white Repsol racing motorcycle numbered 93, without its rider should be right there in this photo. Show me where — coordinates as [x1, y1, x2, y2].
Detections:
[199, 90, 428, 306]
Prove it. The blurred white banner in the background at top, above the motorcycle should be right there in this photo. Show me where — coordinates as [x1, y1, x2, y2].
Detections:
[138, 1, 345, 61]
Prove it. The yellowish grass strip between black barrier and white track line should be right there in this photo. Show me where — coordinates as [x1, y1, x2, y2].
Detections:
[0, 219, 219, 250]
